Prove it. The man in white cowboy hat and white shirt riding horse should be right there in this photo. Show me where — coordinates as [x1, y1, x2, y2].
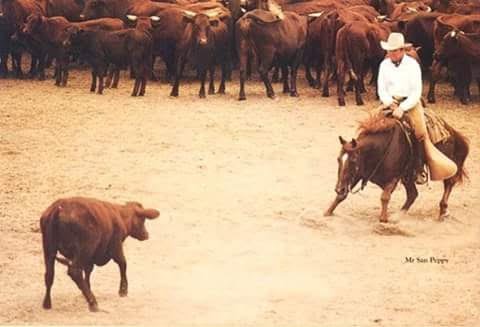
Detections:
[377, 33, 428, 184]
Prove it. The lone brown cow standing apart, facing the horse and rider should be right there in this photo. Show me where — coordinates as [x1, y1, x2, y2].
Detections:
[40, 197, 160, 311]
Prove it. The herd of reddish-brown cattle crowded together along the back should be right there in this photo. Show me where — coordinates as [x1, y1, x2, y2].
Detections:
[0, 0, 480, 105]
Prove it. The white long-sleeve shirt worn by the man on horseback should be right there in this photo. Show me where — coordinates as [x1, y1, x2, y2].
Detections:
[377, 55, 422, 111]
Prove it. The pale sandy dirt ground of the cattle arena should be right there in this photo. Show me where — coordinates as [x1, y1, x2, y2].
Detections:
[0, 67, 480, 327]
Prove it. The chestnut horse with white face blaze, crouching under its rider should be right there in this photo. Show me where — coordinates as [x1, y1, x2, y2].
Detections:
[324, 116, 469, 222]
